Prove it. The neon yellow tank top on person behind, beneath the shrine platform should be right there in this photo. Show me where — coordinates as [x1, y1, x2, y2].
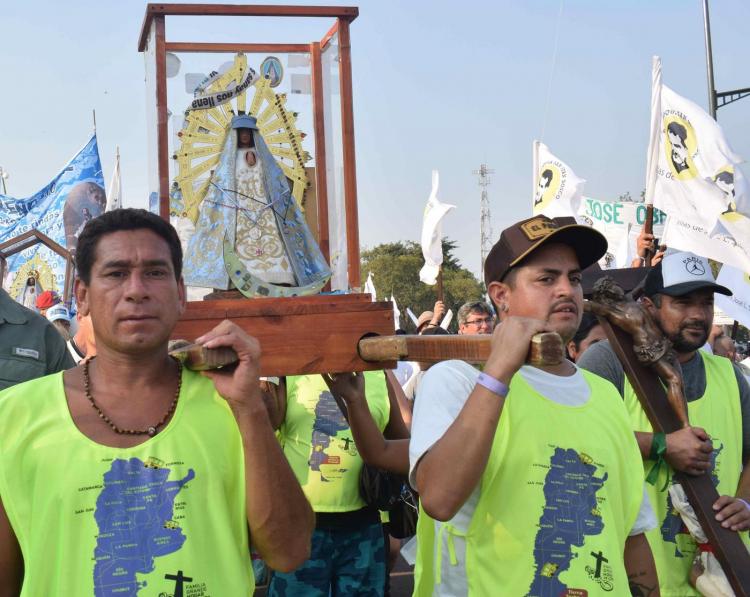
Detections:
[280, 371, 390, 512]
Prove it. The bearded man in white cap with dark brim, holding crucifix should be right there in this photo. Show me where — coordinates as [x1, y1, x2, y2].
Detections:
[578, 251, 750, 597]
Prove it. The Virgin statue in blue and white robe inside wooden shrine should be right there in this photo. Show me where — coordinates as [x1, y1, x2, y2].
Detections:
[185, 114, 331, 296]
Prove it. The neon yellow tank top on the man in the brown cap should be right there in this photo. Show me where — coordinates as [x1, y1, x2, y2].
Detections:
[414, 371, 643, 597]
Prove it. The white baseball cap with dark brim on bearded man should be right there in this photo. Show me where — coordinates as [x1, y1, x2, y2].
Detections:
[643, 250, 732, 296]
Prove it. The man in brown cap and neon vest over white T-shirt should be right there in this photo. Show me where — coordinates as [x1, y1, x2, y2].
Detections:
[409, 216, 658, 596]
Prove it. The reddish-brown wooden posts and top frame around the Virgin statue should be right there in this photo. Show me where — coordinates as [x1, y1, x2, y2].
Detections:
[138, 4, 361, 288]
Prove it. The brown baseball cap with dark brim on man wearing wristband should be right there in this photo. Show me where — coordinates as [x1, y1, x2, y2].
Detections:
[484, 215, 607, 286]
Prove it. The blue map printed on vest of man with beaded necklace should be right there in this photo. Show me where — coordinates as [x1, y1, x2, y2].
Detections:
[94, 458, 195, 597]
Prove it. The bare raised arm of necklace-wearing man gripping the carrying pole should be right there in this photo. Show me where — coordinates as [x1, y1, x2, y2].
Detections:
[196, 320, 315, 572]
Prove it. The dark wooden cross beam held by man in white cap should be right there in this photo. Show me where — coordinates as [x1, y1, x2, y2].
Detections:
[599, 317, 750, 597]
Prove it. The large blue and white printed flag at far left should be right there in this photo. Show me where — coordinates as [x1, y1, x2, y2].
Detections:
[0, 134, 107, 302]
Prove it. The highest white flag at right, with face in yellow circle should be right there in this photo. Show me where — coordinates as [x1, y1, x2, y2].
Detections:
[646, 56, 742, 230]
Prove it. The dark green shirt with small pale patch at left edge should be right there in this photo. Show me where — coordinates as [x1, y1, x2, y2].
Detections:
[0, 288, 75, 390]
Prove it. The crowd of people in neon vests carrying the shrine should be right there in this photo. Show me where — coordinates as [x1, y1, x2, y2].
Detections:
[0, 209, 750, 597]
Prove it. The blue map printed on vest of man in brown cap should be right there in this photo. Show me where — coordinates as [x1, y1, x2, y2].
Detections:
[528, 448, 607, 597]
